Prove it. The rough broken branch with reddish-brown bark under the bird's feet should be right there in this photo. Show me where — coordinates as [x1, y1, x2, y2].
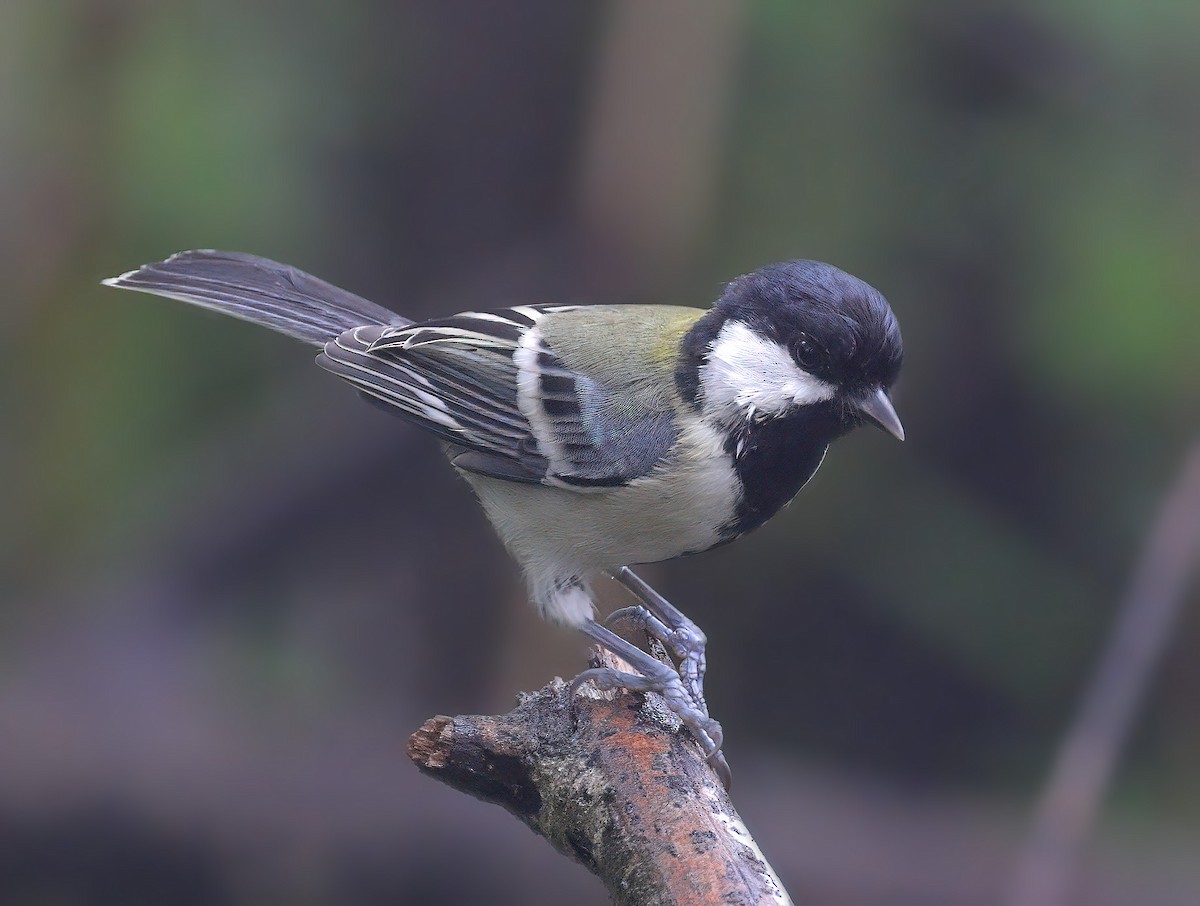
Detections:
[408, 655, 791, 906]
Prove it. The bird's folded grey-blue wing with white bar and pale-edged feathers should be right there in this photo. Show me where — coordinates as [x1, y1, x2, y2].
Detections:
[317, 306, 677, 490]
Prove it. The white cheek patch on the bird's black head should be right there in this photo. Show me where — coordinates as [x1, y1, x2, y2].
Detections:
[701, 320, 838, 420]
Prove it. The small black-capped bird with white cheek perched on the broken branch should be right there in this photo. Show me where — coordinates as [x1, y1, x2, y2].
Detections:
[103, 250, 905, 787]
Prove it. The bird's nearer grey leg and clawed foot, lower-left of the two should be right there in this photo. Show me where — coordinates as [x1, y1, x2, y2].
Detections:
[571, 620, 732, 790]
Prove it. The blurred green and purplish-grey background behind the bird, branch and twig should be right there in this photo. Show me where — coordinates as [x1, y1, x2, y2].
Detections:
[0, 0, 1200, 906]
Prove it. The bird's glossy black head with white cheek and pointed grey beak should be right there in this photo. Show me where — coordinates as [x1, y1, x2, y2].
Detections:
[679, 260, 904, 440]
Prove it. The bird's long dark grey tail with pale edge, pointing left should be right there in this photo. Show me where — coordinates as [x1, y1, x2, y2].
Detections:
[104, 248, 412, 347]
